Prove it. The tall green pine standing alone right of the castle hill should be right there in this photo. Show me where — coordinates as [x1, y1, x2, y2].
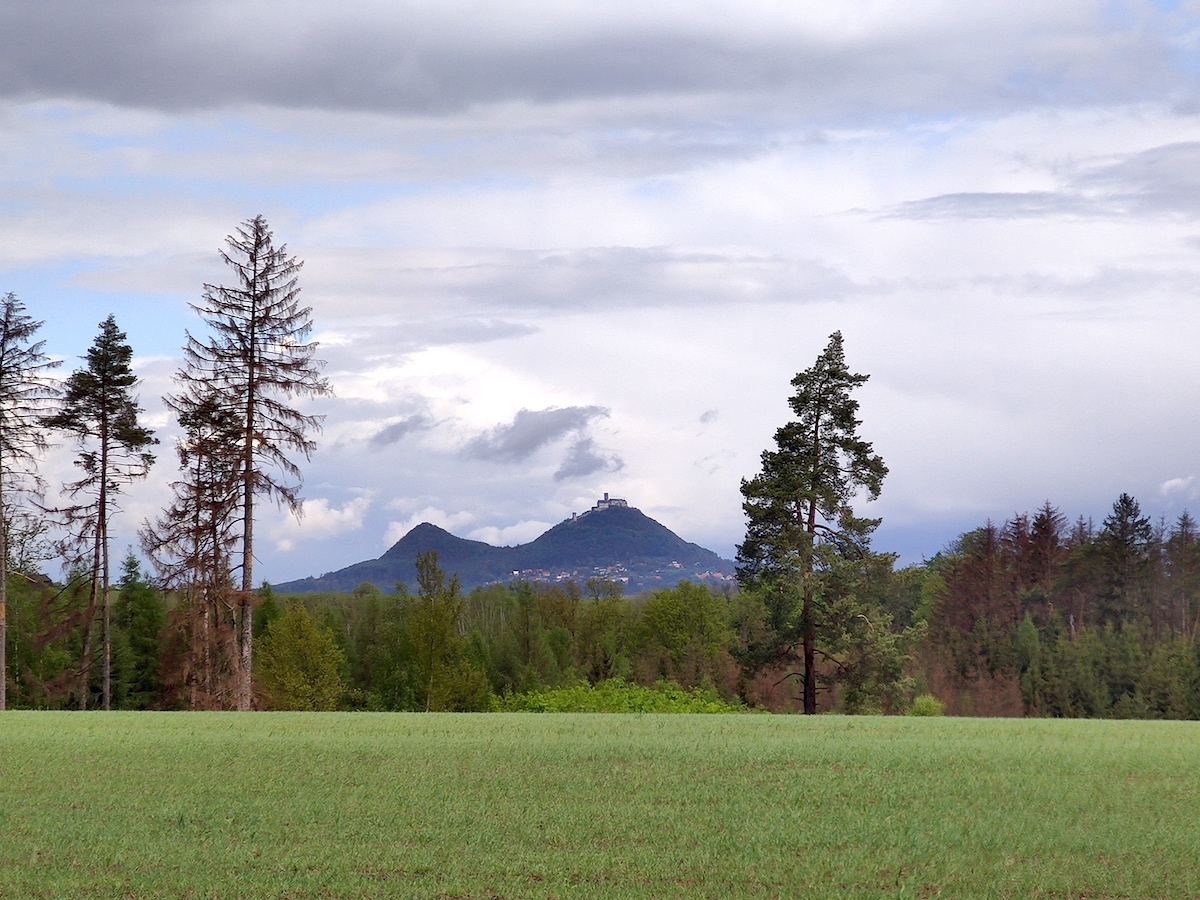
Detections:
[738, 331, 888, 714]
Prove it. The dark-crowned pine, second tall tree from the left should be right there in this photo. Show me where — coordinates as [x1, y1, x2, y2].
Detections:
[43, 316, 158, 709]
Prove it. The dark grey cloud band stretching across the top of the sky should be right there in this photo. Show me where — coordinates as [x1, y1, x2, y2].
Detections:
[0, 0, 1182, 119]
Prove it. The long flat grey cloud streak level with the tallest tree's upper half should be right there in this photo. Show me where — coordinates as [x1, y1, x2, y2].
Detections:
[306, 247, 863, 321]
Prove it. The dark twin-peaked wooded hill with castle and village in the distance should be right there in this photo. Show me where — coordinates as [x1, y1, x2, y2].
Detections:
[275, 506, 733, 593]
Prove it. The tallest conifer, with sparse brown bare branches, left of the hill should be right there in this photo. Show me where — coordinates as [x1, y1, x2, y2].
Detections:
[180, 216, 331, 709]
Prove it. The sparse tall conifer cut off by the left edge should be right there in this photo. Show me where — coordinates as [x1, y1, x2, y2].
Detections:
[0, 292, 59, 709]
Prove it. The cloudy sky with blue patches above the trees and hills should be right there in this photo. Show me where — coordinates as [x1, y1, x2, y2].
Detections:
[0, 0, 1200, 582]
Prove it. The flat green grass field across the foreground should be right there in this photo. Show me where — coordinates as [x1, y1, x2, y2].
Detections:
[0, 712, 1200, 899]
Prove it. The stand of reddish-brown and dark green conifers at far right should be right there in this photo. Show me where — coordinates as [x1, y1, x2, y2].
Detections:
[928, 494, 1200, 719]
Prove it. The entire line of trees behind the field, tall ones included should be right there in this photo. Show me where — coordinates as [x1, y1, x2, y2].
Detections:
[0, 267, 1200, 718]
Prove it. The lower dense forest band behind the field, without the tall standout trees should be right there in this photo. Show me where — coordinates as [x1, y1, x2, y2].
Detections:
[10, 496, 1200, 719]
